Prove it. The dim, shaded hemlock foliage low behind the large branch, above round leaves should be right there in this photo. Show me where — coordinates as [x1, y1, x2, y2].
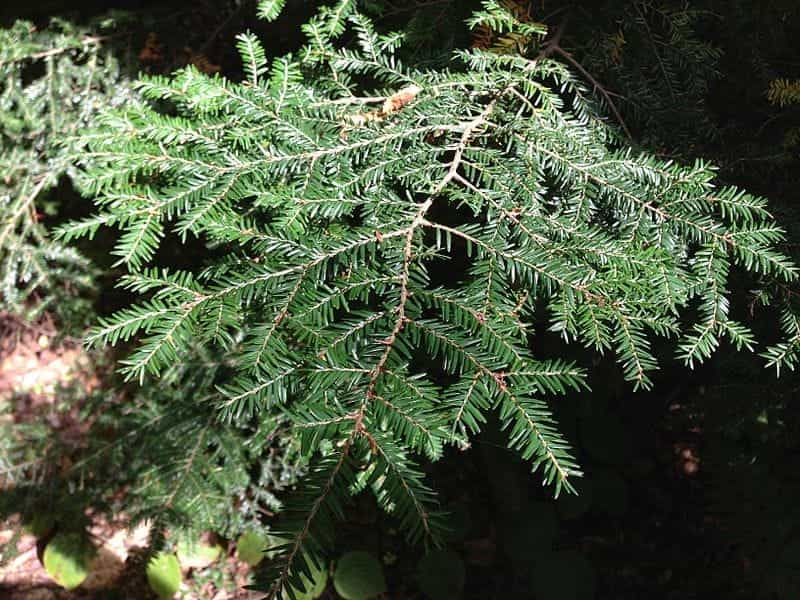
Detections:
[0, 338, 305, 550]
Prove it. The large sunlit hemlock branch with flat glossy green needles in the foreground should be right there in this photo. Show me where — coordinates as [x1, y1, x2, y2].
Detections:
[45, 0, 800, 597]
